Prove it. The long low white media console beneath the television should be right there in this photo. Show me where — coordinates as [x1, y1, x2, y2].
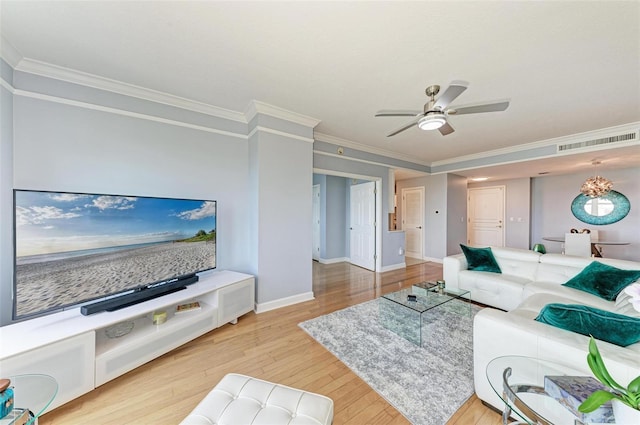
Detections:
[0, 270, 255, 410]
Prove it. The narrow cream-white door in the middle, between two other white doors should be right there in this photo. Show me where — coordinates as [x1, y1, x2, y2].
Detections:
[402, 187, 424, 260]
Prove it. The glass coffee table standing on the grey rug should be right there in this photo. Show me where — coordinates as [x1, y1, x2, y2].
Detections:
[378, 282, 471, 346]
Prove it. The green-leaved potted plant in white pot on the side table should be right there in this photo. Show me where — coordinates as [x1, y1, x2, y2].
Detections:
[578, 337, 640, 424]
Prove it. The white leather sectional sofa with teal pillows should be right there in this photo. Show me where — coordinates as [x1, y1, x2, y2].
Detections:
[443, 248, 640, 409]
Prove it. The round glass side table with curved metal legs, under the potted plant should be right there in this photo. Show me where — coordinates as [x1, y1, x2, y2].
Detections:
[486, 356, 612, 425]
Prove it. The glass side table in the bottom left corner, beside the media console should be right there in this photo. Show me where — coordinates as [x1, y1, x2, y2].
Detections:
[0, 374, 58, 425]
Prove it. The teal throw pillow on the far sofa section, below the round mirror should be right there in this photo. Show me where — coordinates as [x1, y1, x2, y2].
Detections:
[563, 261, 640, 301]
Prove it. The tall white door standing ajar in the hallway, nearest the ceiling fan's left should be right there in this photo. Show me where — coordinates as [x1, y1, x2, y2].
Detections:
[349, 182, 376, 271]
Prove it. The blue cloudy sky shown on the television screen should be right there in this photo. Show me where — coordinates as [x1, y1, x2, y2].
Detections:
[15, 191, 216, 257]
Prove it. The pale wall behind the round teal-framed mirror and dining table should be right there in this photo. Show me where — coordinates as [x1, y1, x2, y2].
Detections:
[531, 167, 640, 261]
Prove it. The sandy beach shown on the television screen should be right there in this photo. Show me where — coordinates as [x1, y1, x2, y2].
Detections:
[15, 241, 216, 317]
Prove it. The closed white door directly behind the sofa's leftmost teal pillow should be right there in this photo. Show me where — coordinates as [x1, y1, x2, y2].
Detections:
[467, 186, 505, 246]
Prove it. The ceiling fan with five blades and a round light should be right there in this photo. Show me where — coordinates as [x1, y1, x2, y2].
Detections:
[375, 80, 509, 137]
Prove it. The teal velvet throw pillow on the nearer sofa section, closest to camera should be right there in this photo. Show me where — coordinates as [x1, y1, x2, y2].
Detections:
[535, 303, 640, 347]
